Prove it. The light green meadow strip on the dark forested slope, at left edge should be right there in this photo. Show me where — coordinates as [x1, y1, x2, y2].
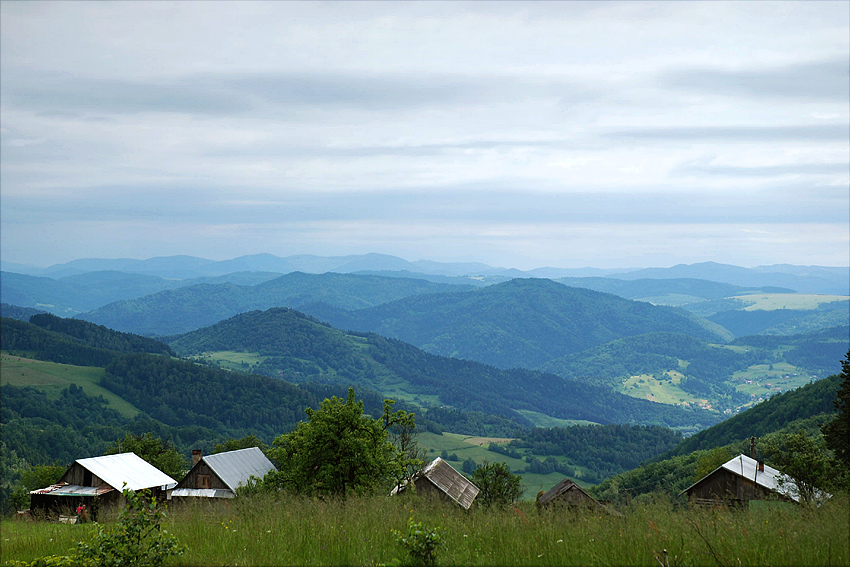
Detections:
[0, 351, 139, 418]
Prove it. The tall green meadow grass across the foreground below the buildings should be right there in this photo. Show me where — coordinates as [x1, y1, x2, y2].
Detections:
[2, 495, 850, 567]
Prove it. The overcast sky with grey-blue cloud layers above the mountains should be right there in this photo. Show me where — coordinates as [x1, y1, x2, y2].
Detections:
[0, 0, 850, 269]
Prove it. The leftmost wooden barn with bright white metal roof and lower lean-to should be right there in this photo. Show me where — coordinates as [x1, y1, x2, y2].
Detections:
[30, 453, 177, 520]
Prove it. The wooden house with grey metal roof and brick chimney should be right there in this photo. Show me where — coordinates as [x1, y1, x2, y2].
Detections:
[170, 447, 275, 500]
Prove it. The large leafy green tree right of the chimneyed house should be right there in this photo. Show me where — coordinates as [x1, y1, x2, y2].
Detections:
[264, 388, 406, 497]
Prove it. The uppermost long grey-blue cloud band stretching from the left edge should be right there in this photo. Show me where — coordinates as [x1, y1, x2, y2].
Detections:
[2, 68, 594, 118]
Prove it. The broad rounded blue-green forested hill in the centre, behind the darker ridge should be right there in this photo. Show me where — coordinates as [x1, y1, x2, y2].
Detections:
[307, 279, 731, 368]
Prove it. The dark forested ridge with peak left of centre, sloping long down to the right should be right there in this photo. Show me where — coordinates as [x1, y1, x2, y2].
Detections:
[170, 306, 717, 427]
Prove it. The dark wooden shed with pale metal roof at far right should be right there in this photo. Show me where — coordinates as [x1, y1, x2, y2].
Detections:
[681, 454, 800, 506]
